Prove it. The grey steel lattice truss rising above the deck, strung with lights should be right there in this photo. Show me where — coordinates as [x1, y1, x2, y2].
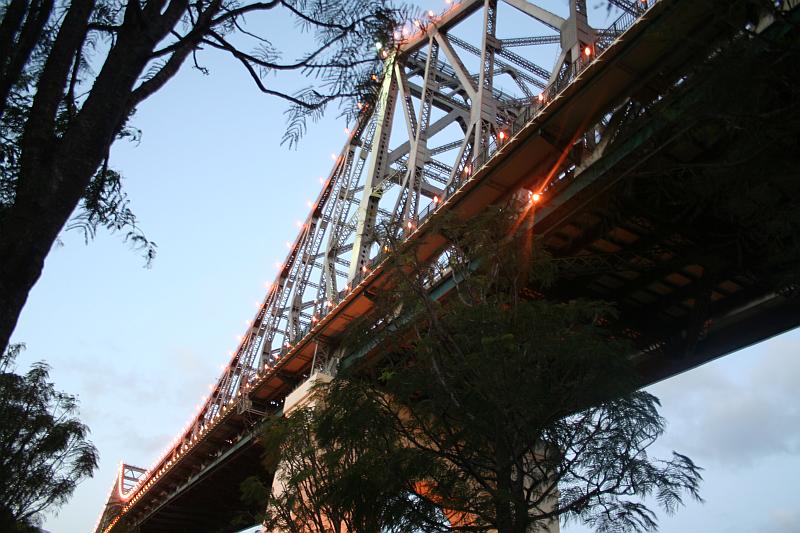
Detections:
[97, 0, 692, 531]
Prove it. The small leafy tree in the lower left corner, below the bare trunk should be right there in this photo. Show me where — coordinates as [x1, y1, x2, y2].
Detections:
[0, 344, 98, 531]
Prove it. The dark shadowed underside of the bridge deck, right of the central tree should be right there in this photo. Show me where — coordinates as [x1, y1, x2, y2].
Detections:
[530, 9, 800, 382]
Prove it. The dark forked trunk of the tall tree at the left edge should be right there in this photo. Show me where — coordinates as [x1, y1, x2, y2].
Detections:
[0, 0, 192, 350]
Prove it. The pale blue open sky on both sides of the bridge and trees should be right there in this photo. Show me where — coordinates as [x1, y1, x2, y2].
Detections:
[7, 0, 800, 533]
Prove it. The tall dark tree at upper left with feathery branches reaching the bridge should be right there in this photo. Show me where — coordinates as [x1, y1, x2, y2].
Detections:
[0, 0, 404, 349]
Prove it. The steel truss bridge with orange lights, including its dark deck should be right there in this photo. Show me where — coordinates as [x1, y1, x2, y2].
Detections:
[96, 0, 800, 532]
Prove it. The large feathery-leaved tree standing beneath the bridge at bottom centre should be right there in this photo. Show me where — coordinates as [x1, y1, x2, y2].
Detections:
[272, 208, 701, 533]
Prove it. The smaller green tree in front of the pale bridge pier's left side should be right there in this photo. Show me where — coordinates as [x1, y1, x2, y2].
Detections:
[239, 404, 441, 533]
